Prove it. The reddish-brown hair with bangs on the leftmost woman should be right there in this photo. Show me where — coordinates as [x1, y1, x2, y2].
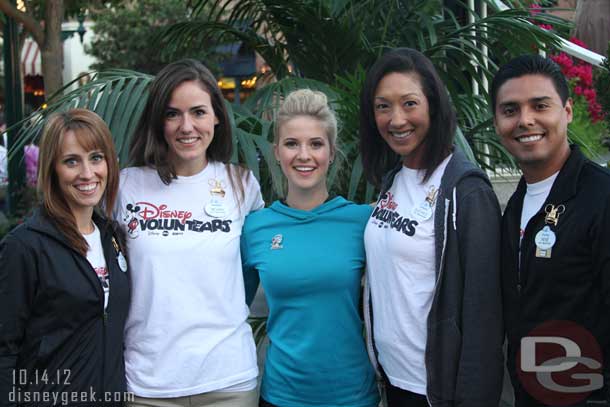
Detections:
[38, 109, 119, 256]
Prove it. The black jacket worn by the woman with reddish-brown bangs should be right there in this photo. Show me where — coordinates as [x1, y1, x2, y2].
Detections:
[0, 212, 130, 407]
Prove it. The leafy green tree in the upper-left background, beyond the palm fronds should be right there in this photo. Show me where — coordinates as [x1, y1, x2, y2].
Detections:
[86, 0, 220, 74]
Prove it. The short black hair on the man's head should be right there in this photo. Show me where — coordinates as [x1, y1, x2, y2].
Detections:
[489, 54, 570, 116]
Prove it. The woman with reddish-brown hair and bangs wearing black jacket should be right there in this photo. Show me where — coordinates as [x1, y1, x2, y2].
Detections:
[0, 109, 130, 406]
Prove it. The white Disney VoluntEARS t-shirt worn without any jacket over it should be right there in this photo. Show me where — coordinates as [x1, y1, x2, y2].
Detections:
[115, 162, 264, 397]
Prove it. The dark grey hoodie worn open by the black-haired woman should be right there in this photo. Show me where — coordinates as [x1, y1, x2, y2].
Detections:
[364, 149, 504, 407]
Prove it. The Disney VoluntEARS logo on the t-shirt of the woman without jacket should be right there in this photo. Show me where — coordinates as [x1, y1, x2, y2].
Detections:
[123, 201, 233, 239]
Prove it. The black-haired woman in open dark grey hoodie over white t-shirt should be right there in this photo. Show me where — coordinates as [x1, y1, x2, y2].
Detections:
[360, 48, 503, 407]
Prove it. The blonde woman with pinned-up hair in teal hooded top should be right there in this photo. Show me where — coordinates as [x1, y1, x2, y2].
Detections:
[241, 89, 379, 407]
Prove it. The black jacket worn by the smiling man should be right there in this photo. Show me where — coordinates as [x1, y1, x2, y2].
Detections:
[502, 146, 610, 406]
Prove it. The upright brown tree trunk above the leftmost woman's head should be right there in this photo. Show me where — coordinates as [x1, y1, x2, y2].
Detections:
[39, 0, 64, 100]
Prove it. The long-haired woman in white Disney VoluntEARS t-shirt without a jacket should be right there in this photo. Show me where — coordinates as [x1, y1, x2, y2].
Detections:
[115, 59, 263, 407]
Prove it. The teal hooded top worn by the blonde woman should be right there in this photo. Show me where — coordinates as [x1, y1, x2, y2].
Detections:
[241, 197, 379, 407]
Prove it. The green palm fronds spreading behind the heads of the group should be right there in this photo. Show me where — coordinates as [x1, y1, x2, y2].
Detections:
[7, 0, 565, 202]
